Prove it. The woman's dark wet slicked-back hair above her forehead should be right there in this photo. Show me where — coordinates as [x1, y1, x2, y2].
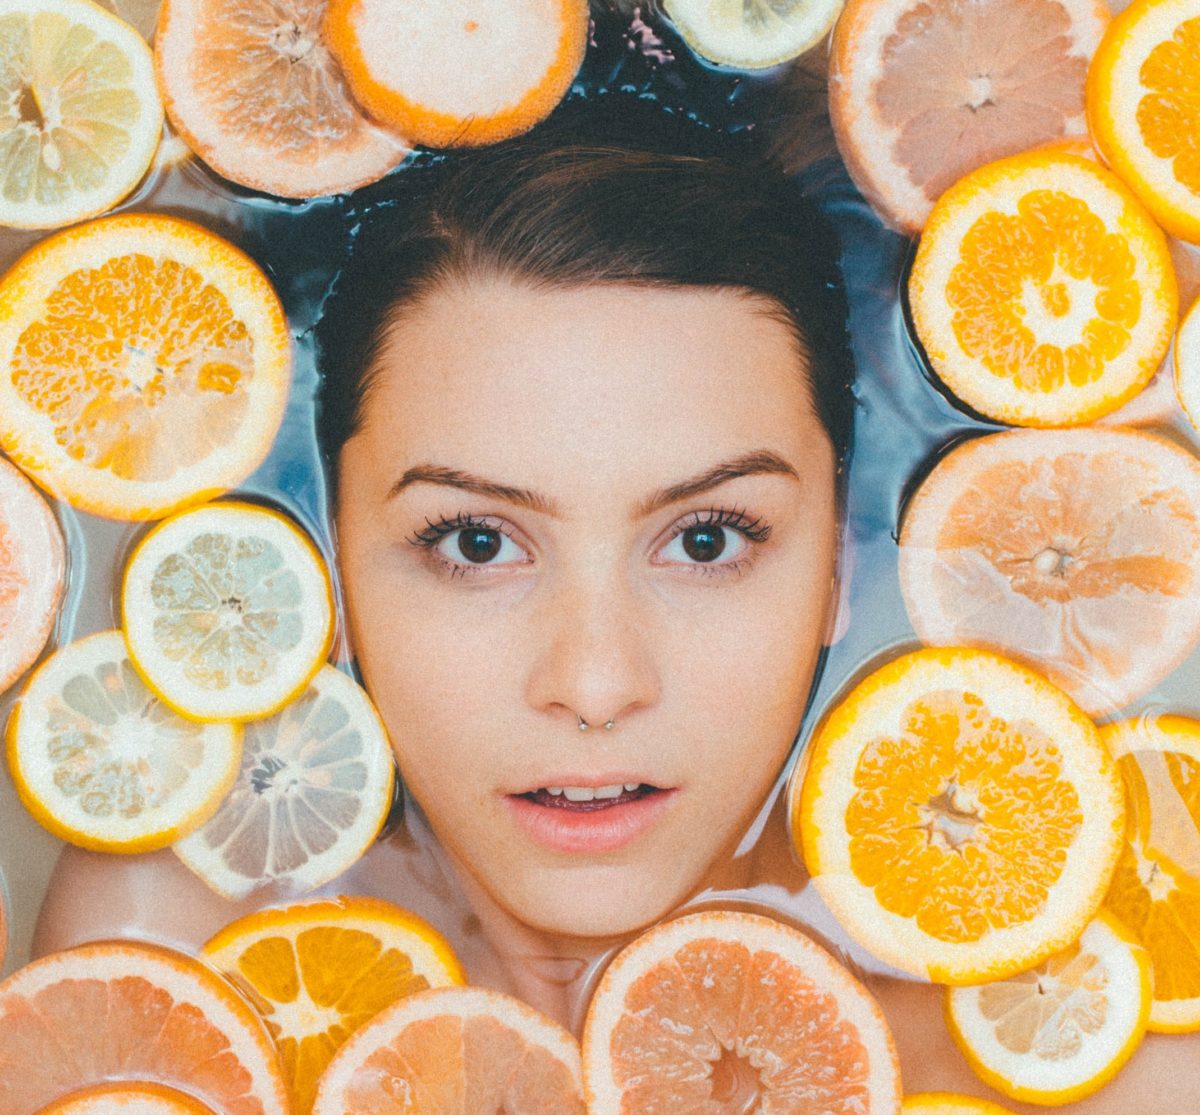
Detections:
[316, 101, 853, 492]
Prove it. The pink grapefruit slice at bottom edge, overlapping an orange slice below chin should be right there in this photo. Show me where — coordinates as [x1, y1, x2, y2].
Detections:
[313, 988, 583, 1115]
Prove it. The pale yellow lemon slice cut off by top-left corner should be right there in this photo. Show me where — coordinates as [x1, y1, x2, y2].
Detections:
[0, 0, 162, 228]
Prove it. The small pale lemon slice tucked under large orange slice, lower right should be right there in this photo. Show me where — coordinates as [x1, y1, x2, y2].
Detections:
[946, 913, 1151, 1103]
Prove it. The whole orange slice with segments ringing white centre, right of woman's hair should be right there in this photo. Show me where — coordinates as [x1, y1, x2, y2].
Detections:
[908, 149, 1178, 426]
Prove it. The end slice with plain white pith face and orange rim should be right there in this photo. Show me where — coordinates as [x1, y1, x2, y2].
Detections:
[324, 0, 588, 146]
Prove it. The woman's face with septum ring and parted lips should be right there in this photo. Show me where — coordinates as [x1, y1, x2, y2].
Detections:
[337, 278, 836, 936]
